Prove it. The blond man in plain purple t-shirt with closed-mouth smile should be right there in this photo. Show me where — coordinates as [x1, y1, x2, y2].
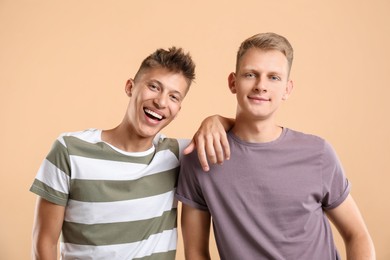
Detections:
[176, 33, 375, 260]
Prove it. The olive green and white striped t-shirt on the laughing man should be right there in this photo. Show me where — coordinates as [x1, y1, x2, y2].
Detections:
[30, 129, 188, 260]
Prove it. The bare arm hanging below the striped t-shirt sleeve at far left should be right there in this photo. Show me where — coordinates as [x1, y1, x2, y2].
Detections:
[32, 197, 65, 260]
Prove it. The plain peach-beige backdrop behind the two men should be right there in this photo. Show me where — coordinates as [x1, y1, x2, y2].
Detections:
[0, 0, 390, 260]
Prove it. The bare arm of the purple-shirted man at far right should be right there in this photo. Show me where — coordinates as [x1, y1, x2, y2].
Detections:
[327, 195, 375, 260]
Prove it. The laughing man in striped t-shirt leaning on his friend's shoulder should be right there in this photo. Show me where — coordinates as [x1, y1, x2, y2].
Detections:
[30, 47, 230, 260]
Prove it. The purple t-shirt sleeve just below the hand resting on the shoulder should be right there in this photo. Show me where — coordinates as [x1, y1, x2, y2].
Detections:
[176, 151, 208, 211]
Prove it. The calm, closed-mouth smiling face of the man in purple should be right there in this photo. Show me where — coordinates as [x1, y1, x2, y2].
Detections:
[229, 48, 292, 122]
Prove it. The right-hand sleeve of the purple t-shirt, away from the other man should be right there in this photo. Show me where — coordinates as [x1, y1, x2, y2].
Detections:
[322, 142, 351, 210]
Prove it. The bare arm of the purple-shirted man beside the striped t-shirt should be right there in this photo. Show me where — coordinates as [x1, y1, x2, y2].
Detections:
[181, 203, 211, 260]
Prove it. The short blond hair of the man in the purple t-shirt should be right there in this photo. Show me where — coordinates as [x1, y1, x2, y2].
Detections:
[236, 32, 294, 73]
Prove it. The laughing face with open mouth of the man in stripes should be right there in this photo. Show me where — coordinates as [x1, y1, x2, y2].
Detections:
[125, 68, 189, 139]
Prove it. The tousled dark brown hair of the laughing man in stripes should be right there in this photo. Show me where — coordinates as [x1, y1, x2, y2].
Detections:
[134, 47, 195, 86]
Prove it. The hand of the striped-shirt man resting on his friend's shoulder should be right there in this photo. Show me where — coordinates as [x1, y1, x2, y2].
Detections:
[184, 115, 235, 171]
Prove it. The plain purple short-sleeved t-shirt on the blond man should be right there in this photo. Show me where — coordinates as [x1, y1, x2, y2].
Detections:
[176, 128, 350, 260]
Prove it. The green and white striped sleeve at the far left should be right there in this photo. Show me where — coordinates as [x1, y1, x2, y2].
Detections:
[30, 137, 70, 206]
